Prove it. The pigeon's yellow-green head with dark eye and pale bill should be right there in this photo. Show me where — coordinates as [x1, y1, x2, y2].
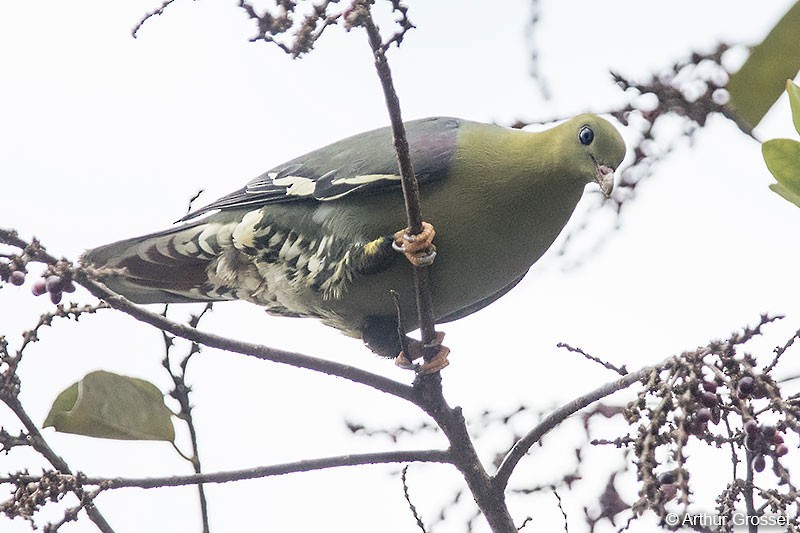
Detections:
[558, 114, 625, 197]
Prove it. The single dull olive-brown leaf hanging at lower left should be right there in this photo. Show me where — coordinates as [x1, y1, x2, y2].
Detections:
[44, 370, 175, 442]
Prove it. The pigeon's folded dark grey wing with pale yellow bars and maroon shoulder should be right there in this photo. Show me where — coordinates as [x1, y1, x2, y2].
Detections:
[181, 117, 461, 221]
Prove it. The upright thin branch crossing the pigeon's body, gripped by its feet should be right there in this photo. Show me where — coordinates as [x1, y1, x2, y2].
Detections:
[347, 1, 436, 361]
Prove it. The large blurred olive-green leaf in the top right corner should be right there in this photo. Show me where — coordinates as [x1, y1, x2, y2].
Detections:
[727, 1, 800, 129]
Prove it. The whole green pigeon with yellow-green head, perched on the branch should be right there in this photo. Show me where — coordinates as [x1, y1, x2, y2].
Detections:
[82, 115, 625, 372]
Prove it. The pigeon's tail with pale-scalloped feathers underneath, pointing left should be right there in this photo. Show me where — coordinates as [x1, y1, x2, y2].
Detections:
[81, 220, 231, 304]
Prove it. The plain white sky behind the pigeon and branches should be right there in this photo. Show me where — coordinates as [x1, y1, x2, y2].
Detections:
[0, 0, 800, 533]
